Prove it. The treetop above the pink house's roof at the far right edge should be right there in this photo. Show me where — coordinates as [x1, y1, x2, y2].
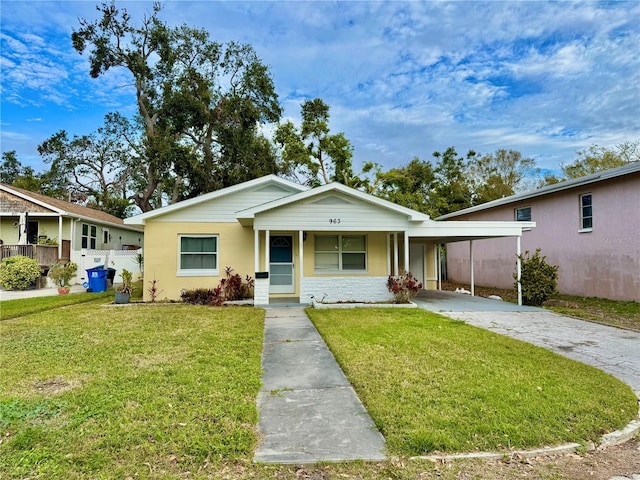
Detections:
[561, 140, 640, 180]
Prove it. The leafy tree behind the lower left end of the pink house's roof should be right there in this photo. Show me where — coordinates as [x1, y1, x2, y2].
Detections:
[468, 149, 539, 205]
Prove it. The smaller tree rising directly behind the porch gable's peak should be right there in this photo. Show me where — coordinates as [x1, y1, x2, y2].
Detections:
[275, 98, 359, 186]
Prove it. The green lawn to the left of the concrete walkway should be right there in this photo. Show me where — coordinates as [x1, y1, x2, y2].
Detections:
[0, 304, 264, 479]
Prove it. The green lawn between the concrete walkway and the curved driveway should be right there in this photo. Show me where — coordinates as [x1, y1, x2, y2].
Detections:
[308, 309, 638, 455]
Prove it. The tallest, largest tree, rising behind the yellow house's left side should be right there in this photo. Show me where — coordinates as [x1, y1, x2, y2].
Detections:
[72, 2, 281, 212]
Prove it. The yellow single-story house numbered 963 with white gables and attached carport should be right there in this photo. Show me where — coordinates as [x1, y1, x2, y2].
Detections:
[125, 175, 535, 305]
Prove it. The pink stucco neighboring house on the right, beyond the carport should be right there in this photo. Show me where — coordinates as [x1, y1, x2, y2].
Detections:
[437, 162, 640, 301]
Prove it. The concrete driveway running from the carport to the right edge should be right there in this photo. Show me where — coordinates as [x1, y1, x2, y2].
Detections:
[415, 292, 640, 396]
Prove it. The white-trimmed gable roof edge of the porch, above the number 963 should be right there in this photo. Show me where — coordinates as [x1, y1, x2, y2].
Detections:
[236, 182, 430, 222]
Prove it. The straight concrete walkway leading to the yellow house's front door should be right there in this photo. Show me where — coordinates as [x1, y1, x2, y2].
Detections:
[254, 307, 386, 463]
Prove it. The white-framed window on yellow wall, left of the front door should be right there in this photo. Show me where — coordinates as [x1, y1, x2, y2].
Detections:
[178, 235, 218, 276]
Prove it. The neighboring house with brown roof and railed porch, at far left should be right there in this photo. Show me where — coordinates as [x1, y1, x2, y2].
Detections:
[0, 183, 144, 283]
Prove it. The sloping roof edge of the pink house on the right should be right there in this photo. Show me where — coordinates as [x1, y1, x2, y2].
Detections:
[436, 161, 640, 220]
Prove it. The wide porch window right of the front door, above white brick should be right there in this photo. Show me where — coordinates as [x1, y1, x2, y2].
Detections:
[315, 235, 367, 272]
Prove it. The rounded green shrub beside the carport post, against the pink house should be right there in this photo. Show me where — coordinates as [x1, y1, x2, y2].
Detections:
[513, 248, 558, 306]
